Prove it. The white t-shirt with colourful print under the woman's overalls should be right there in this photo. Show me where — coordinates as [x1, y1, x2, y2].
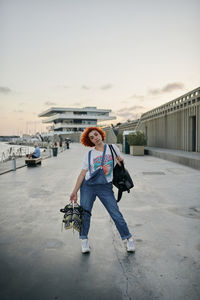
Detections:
[82, 145, 123, 182]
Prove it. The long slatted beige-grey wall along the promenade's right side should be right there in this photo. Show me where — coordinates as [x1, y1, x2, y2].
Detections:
[139, 88, 200, 152]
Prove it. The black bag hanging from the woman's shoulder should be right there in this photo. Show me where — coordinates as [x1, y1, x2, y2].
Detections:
[109, 145, 134, 202]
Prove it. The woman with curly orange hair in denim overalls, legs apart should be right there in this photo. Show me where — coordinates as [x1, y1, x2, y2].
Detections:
[70, 127, 135, 253]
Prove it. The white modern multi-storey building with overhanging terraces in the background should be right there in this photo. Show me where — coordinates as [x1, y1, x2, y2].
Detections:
[39, 106, 116, 135]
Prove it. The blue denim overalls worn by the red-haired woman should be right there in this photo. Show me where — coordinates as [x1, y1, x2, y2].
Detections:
[80, 144, 131, 240]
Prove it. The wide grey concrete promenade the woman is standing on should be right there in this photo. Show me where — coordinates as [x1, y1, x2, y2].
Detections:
[0, 143, 200, 300]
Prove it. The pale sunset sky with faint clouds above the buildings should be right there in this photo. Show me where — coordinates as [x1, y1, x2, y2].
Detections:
[0, 0, 200, 135]
